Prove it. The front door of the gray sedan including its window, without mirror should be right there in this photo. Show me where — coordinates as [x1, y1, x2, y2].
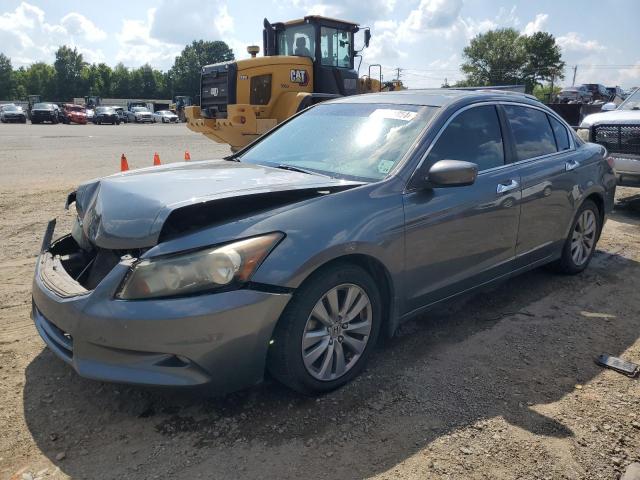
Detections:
[403, 104, 521, 313]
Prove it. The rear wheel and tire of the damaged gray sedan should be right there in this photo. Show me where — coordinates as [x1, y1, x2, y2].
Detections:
[549, 200, 602, 275]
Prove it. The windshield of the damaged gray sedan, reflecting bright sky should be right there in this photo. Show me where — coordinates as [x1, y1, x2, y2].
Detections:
[240, 103, 437, 181]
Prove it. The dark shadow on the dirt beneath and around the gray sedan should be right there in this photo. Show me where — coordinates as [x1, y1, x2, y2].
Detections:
[24, 251, 640, 478]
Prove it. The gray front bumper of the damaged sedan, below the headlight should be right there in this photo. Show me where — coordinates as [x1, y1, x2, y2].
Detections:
[32, 236, 290, 392]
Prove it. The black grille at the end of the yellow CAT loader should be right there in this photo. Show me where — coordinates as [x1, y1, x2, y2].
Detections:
[200, 62, 237, 118]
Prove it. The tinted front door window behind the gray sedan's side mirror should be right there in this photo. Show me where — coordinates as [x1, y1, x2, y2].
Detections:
[428, 105, 504, 171]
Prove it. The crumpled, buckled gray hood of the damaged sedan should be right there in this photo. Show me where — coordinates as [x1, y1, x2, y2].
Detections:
[75, 160, 360, 249]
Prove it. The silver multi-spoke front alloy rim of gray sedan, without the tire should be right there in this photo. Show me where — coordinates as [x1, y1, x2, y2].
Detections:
[302, 283, 372, 381]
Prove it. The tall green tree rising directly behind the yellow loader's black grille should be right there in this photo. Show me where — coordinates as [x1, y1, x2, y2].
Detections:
[169, 40, 235, 97]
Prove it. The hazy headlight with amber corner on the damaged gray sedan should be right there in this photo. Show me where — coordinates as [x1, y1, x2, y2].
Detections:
[116, 233, 284, 300]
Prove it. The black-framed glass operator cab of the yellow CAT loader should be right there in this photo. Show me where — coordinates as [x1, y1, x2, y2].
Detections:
[263, 15, 370, 96]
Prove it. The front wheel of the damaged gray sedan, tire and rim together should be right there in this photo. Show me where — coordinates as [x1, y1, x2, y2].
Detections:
[267, 264, 382, 395]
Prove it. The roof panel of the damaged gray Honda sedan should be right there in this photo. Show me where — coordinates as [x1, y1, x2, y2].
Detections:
[331, 88, 539, 107]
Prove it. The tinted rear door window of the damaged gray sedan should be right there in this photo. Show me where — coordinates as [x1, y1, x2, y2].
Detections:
[504, 105, 557, 160]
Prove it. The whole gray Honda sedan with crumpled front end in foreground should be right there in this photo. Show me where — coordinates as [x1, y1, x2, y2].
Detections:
[33, 90, 615, 393]
